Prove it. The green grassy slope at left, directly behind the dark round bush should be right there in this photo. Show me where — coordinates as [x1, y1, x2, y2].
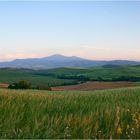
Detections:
[0, 69, 75, 86]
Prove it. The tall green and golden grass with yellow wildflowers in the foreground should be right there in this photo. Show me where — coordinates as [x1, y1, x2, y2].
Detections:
[0, 88, 140, 138]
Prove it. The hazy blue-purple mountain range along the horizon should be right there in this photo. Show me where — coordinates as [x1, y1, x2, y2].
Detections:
[0, 54, 140, 69]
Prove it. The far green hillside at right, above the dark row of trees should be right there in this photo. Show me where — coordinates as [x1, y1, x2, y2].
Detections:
[38, 66, 140, 79]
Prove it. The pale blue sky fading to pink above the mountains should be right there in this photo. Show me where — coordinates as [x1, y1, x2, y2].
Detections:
[0, 1, 140, 61]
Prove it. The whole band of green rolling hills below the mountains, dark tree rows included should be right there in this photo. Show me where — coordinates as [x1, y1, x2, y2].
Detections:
[0, 66, 140, 86]
